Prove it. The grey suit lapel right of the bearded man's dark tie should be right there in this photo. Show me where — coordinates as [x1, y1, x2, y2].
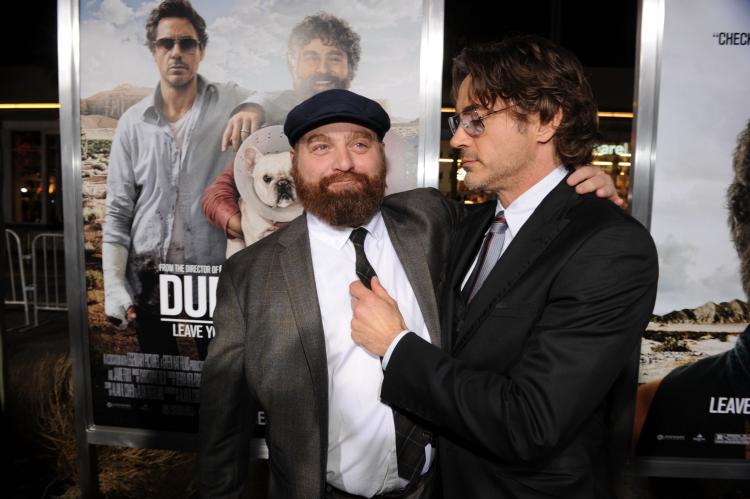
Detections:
[381, 207, 441, 346]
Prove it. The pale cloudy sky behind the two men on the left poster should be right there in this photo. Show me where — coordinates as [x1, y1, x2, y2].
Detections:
[81, 0, 422, 119]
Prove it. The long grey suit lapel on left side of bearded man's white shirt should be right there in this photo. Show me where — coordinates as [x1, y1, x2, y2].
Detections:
[279, 214, 328, 458]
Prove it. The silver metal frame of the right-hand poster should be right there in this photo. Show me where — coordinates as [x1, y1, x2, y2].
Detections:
[625, 0, 750, 480]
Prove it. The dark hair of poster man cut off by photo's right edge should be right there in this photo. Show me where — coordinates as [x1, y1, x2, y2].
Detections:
[727, 121, 750, 296]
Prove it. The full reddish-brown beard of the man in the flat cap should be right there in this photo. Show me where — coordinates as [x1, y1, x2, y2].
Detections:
[292, 155, 386, 227]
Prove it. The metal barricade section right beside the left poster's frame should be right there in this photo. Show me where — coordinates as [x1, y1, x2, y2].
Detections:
[31, 232, 68, 325]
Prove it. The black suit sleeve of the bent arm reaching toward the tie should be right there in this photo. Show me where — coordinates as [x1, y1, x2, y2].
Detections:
[381, 223, 658, 462]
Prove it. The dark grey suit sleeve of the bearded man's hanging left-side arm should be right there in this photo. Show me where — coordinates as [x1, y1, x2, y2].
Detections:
[197, 266, 258, 499]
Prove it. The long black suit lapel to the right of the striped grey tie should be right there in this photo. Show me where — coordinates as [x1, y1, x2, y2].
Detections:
[453, 180, 577, 354]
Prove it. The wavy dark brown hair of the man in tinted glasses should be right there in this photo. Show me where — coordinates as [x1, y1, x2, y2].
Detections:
[453, 35, 599, 165]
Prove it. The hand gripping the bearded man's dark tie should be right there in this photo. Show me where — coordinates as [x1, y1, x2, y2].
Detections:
[349, 277, 407, 357]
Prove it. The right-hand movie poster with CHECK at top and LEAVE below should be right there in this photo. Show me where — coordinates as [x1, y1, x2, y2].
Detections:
[636, 0, 750, 460]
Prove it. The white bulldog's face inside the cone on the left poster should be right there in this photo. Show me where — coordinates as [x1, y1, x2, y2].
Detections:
[244, 147, 297, 208]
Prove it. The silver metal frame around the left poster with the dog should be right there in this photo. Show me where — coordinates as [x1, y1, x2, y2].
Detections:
[57, 0, 444, 488]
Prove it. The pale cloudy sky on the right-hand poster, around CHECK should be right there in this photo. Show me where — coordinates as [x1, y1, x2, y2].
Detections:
[651, 0, 750, 314]
